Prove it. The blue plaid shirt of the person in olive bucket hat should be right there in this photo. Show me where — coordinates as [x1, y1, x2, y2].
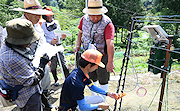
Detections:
[0, 44, 41, 108]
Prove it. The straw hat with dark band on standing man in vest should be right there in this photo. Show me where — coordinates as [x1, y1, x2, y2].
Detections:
[83, 0, 108, 15]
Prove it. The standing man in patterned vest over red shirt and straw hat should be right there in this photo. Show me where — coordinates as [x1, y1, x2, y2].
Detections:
[74, 0, 115, 100]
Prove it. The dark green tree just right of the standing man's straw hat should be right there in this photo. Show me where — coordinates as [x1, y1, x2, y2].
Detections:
[103, 0, 143, 28]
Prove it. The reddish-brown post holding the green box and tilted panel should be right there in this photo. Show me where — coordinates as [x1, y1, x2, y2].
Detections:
[158, 36, 172, 111]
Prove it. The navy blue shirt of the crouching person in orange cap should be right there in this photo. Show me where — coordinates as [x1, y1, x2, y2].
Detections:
[60, 68, 91, 108]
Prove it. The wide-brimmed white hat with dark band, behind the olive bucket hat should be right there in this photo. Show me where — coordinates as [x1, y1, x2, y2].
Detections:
[13, 0, 52, 15]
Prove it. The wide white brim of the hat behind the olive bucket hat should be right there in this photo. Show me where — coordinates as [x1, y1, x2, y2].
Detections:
[13, 8, 52, 15]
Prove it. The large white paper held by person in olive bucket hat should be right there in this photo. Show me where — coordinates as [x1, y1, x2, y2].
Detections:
[32, 43, 64, 68]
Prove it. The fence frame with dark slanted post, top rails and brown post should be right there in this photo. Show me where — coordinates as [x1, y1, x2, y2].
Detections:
[114, 15, 180, 111]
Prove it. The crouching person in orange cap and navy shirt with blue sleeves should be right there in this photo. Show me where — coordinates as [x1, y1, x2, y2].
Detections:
[59, 49, 119, 111]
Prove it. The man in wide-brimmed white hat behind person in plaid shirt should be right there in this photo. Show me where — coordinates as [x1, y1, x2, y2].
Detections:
[13, 0, 53, 110]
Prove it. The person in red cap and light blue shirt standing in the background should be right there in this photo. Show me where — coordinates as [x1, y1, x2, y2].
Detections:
[42, 7, 69, 86]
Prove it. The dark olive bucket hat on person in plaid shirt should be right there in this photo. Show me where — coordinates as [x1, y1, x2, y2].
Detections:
[6, 18, 40, 45]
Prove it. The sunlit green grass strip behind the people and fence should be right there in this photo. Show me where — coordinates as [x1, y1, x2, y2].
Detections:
[55, 46, 180, 77]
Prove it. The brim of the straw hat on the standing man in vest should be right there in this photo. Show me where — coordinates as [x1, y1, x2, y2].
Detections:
[83, 6, 108, 15]
